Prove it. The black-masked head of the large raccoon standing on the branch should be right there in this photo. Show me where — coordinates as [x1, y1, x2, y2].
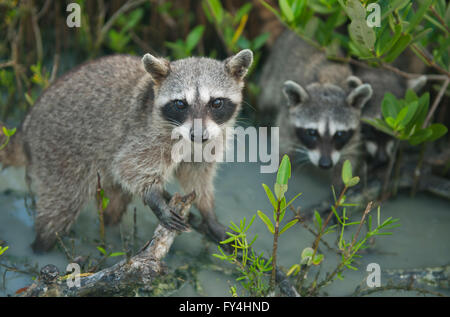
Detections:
[143, 50, 253, 143]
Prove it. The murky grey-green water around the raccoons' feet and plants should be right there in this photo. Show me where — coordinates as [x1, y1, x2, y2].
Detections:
[0, 159, 450, 296]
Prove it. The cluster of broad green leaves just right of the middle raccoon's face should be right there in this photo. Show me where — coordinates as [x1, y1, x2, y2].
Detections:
[364, 90, 447, 145]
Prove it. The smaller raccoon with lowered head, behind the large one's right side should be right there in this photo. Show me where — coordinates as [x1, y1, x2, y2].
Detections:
[258, 31, 372, 177]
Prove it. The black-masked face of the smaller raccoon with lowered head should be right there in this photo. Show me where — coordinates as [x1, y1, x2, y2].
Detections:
[283, 81, 372, 169]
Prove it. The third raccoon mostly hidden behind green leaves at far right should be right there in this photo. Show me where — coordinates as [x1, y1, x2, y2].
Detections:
[349, 67, 427, 168]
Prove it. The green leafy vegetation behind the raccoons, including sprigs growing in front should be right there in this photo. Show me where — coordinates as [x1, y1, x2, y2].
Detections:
[0, 0, 450, 295]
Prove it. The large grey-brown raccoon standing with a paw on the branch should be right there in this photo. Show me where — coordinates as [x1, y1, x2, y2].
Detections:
[1, 50, 253, 251]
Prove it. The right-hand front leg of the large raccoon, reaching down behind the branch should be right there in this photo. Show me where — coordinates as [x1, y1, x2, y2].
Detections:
[176, 162, 226, 241]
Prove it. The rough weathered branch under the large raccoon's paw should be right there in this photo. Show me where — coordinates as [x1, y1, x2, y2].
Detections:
[22, 193, 195, 296]
